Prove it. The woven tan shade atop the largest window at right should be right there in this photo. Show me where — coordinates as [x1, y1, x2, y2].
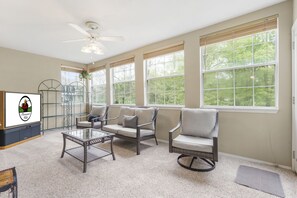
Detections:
[200, 15, 278, 46]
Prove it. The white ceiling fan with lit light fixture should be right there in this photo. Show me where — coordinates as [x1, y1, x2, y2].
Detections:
[63, 21, 124, 55]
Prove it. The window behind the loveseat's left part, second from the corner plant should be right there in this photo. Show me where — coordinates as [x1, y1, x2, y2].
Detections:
[111, 58, 135, 104]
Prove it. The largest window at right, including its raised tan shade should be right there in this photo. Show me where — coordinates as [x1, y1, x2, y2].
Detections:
[200, 17, 277, 109]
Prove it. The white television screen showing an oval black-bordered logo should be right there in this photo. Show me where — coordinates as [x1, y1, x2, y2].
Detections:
[5, 92, 40, 128]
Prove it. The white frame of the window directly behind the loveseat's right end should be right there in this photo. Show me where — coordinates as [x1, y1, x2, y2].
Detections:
[143, 49, 186, 108]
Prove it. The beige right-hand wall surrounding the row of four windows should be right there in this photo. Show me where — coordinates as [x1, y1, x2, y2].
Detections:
[90, 1, 293, 166]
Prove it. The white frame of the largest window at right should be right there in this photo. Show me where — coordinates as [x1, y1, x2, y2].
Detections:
[199, 27, 279, 113]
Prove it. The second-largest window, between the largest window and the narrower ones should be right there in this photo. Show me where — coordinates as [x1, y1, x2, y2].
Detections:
[144, 45, 185, 105]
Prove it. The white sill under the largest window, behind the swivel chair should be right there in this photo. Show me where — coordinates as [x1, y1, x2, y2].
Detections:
[200, 106, 279, 113]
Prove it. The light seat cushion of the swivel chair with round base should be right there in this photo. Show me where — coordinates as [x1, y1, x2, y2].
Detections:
[172, 135, 213, 153]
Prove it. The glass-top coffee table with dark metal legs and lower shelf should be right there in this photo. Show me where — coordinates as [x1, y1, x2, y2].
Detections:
[61, 128, 115, 173]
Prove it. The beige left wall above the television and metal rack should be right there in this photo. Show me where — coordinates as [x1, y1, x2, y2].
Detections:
[0, 48, 83, 93]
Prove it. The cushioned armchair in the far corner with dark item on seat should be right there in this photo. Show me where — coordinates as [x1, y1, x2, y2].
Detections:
[76, 106, 108, 129]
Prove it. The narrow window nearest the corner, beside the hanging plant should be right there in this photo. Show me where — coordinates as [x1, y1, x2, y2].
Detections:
[91, 69, 106, 104]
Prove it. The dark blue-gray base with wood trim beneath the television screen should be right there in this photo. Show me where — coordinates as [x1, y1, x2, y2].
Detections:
[0, 122, 40, 150]
